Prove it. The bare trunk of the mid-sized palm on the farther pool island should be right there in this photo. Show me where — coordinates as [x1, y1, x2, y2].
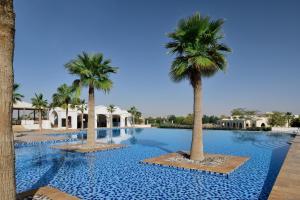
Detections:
[87, 85, 96, 146]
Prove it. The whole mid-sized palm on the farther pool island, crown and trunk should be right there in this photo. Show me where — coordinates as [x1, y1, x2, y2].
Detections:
[65, 52, 117, 145]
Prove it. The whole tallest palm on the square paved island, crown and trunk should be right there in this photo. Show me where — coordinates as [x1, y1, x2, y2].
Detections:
[166, 13, 231, 160]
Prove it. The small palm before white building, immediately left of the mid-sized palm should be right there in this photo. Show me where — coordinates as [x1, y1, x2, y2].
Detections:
[52, 83, 74, 129]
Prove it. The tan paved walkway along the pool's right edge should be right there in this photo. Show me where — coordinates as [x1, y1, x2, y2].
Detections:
[269, 135, 300, 200]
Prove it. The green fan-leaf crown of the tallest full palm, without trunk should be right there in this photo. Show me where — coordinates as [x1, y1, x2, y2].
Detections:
[166, 13, 231, 84]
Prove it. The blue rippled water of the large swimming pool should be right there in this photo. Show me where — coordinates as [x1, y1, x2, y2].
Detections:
[16, 129, 291, 199]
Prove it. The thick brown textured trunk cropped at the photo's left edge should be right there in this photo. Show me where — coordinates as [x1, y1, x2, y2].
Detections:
[0, 0, 16, 200]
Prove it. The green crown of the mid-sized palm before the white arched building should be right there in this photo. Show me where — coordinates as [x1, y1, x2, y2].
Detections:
[65, 52, 117, 92]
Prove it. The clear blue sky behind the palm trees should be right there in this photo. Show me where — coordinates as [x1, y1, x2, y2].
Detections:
[14, 0, 300, 116]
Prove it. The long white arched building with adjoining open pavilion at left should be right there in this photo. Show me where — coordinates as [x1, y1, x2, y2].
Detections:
[13, 102, 132, 129]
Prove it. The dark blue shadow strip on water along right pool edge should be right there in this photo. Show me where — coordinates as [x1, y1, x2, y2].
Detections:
[258, 145, 289, 200]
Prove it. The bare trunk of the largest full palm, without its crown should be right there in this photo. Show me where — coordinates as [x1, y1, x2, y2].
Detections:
[190, 73, 204, 161]
